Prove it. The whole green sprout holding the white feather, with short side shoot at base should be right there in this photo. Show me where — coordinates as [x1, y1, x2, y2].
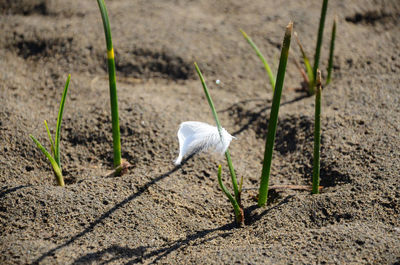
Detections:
[194, 63, 244, 225]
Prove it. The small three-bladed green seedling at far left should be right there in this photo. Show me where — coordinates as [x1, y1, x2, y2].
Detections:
[29, 75, 71, 186]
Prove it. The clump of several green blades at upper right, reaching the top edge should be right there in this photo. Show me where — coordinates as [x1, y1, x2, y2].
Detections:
[295, 0, 336, 95]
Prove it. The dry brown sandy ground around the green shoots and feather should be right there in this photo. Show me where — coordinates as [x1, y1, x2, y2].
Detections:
[0, 0, 400, 264]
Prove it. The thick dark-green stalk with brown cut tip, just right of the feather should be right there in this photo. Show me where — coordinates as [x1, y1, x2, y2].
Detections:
[258, 22, 293, 207]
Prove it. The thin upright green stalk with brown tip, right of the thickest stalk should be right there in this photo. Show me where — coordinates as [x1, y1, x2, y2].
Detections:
[312, 70, 322, 194]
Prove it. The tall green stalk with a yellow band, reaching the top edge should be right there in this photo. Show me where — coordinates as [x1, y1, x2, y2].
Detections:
[97, 0, 121, 169]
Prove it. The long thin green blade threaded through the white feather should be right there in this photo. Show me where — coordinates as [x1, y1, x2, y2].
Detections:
[194, 63, 240, 203]
